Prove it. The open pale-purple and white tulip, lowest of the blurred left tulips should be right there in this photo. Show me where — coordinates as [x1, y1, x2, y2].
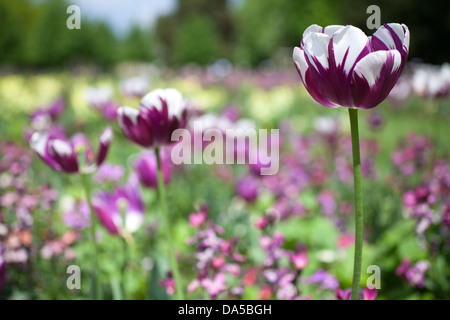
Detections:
[92, 174, 144, 235]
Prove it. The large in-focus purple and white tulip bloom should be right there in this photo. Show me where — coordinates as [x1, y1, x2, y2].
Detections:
[293, 23, 409, 109]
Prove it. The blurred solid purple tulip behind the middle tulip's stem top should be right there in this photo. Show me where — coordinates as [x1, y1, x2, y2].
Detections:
[134, 149, 173, 189]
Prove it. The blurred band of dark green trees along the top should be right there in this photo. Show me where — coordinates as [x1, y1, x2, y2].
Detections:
[0, 0, 450, 67]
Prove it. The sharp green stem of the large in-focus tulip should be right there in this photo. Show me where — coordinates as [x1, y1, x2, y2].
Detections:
[348, 109, 363, 300]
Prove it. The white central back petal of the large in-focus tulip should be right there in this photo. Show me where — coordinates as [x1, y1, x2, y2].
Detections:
[333, 26, 369, 74]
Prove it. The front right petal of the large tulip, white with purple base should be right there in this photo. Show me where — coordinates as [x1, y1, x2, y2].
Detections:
[352, 50, 402, 109]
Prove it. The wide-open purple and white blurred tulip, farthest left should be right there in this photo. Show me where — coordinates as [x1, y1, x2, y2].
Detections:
[30, 127, 113, 173]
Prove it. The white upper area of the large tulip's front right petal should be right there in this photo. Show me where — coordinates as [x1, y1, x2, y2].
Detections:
[354, 50, 402, 87]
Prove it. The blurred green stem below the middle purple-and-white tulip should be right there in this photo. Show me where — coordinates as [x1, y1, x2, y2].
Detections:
[155, 148, 184, 300]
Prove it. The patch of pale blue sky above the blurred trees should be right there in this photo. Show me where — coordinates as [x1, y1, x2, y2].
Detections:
[69, 0, 176, 35]
